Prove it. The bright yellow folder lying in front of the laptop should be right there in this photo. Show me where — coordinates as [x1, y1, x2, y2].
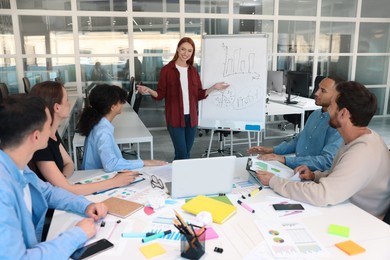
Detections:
[181, 195, 237, 224]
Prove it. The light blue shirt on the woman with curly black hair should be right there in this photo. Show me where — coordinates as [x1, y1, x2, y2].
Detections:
[81, 117, 144, 172]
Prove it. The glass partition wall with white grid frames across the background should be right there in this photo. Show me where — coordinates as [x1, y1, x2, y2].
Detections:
[0, 0, 390, 120]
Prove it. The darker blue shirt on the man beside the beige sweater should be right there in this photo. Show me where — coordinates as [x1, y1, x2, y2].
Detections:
[274, 109, 343, 171]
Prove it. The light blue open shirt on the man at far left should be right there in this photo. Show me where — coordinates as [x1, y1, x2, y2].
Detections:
[0, 150, 91, 259]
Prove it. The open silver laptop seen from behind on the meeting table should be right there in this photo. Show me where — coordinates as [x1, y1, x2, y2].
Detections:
[165, 156, 236, 199]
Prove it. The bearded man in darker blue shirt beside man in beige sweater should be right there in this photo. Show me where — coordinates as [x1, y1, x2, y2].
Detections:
[248, 77, 342, 171]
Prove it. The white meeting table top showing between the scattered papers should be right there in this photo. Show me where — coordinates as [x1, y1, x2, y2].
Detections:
[48, 157, 390, 259]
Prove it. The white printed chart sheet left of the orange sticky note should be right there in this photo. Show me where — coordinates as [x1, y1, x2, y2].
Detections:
[256, 221, 327, 258]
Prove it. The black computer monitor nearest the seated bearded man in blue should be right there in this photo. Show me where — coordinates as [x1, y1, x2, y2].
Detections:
[286, 71, 309, 104]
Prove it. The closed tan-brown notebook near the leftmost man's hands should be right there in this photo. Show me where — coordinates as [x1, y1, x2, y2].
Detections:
[102, 197, 144, 218]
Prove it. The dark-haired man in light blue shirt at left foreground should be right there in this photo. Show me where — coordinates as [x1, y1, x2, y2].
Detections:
[0, 94, 107, 259]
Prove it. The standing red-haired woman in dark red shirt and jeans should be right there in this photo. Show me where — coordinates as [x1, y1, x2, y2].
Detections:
[138, 37, 229, 160]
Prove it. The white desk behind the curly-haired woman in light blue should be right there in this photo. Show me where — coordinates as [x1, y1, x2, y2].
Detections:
[73, 103, 153, 169]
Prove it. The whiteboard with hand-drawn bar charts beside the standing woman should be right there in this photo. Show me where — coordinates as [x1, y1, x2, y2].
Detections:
[199, 34, 267, 131]
